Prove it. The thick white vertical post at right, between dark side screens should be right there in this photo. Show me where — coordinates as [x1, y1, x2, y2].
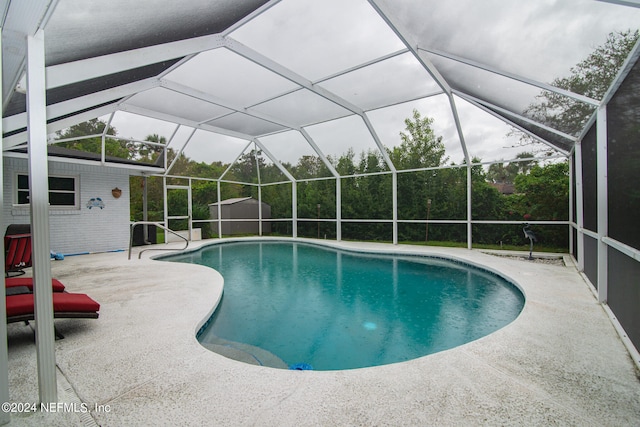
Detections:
[596, 105, 609, 304]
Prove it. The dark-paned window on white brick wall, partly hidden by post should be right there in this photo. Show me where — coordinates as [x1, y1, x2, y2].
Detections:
[15, 174, 80, 209]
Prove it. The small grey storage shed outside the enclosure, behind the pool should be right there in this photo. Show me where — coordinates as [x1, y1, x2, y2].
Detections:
[209, 197, 271, 236]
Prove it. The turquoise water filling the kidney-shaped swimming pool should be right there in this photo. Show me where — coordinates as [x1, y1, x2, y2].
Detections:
[168, 241, 524, 370]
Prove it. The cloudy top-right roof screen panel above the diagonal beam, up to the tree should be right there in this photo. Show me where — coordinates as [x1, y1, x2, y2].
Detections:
[384, 0, 640, 90]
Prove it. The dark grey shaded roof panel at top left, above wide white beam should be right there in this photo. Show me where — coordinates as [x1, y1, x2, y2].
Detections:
[45, 0, 267, 65]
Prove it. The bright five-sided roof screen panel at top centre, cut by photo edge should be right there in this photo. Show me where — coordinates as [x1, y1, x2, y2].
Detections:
[230, 0, 404, 82]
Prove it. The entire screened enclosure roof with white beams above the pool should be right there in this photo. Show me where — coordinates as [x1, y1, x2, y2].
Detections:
[0, 0, 640, 174]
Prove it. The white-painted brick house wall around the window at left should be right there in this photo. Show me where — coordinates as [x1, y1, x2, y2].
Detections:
[0, 157, 130, 254]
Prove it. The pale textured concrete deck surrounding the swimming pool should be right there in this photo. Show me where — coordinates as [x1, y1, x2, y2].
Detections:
[8, 239, 640, 426]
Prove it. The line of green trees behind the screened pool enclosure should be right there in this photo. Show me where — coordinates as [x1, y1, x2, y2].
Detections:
[59, 111, 568, 248]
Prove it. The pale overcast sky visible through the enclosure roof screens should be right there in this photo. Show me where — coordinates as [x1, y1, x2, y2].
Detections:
[106, 0, 640, 174]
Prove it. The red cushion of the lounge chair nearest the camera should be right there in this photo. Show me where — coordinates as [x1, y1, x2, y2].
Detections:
[6, 292, 100, 338]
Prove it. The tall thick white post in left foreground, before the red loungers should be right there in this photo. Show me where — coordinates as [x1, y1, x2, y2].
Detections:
[27, 30, 58, 403]
